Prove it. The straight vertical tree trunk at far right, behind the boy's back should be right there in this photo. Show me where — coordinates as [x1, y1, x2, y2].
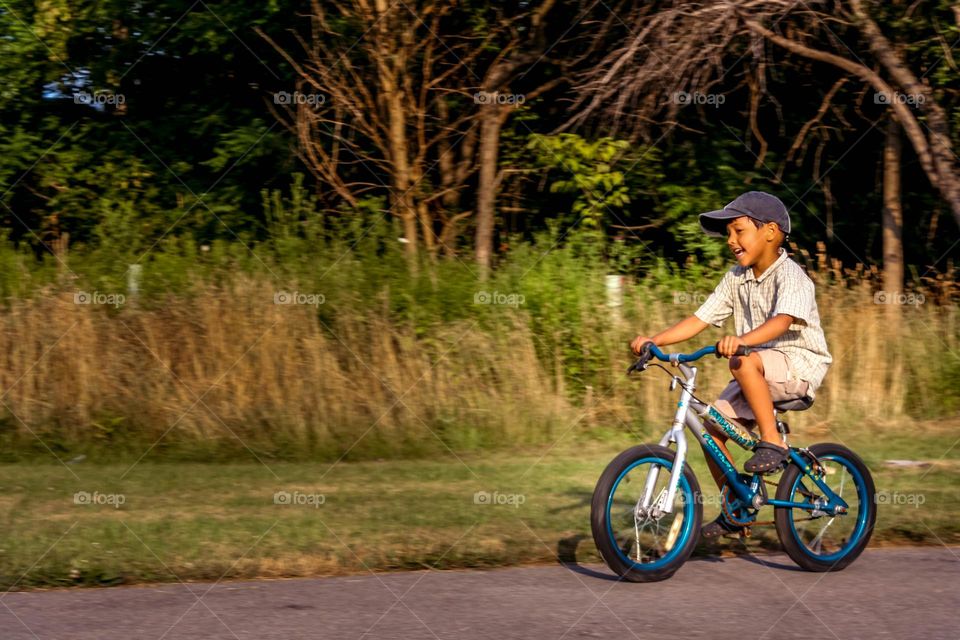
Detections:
[883, 118, 903, 317]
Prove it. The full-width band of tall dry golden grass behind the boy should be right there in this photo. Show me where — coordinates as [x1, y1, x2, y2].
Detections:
[0, 264, 960, 459]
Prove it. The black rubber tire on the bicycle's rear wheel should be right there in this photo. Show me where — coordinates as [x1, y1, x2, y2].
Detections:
[774, 442, 877, 573]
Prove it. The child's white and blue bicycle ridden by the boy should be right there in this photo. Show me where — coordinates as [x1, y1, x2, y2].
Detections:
[590, 342, 877, 582]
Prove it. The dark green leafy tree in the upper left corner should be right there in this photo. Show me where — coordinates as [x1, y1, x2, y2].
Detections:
[0, 0, 296, 255]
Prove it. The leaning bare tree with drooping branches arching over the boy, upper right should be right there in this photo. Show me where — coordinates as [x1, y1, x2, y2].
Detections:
[570, 0, 960, 230]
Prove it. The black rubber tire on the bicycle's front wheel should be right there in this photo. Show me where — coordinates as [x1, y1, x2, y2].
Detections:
[590, 444, 703, 582]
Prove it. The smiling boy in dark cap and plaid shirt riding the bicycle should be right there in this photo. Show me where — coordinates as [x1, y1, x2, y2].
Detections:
[630, 191, 833, 538]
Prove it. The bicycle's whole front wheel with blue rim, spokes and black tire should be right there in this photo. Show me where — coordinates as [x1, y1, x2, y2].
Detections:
[590, 444, 703, 582]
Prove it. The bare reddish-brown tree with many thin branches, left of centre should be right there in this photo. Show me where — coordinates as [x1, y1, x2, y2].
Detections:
[261, 0, 492, 258]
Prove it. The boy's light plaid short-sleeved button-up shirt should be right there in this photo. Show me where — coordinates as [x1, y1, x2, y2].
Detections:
[694, 248, 833, 398]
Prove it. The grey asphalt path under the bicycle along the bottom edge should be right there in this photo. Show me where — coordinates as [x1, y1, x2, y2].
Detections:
[0, 547, 960, 640]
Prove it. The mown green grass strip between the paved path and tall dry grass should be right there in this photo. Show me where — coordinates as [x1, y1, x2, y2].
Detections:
[0, 421, 960, 589]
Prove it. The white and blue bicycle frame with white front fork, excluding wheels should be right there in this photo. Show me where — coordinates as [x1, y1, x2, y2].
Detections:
[637, 358, 848, 515]
